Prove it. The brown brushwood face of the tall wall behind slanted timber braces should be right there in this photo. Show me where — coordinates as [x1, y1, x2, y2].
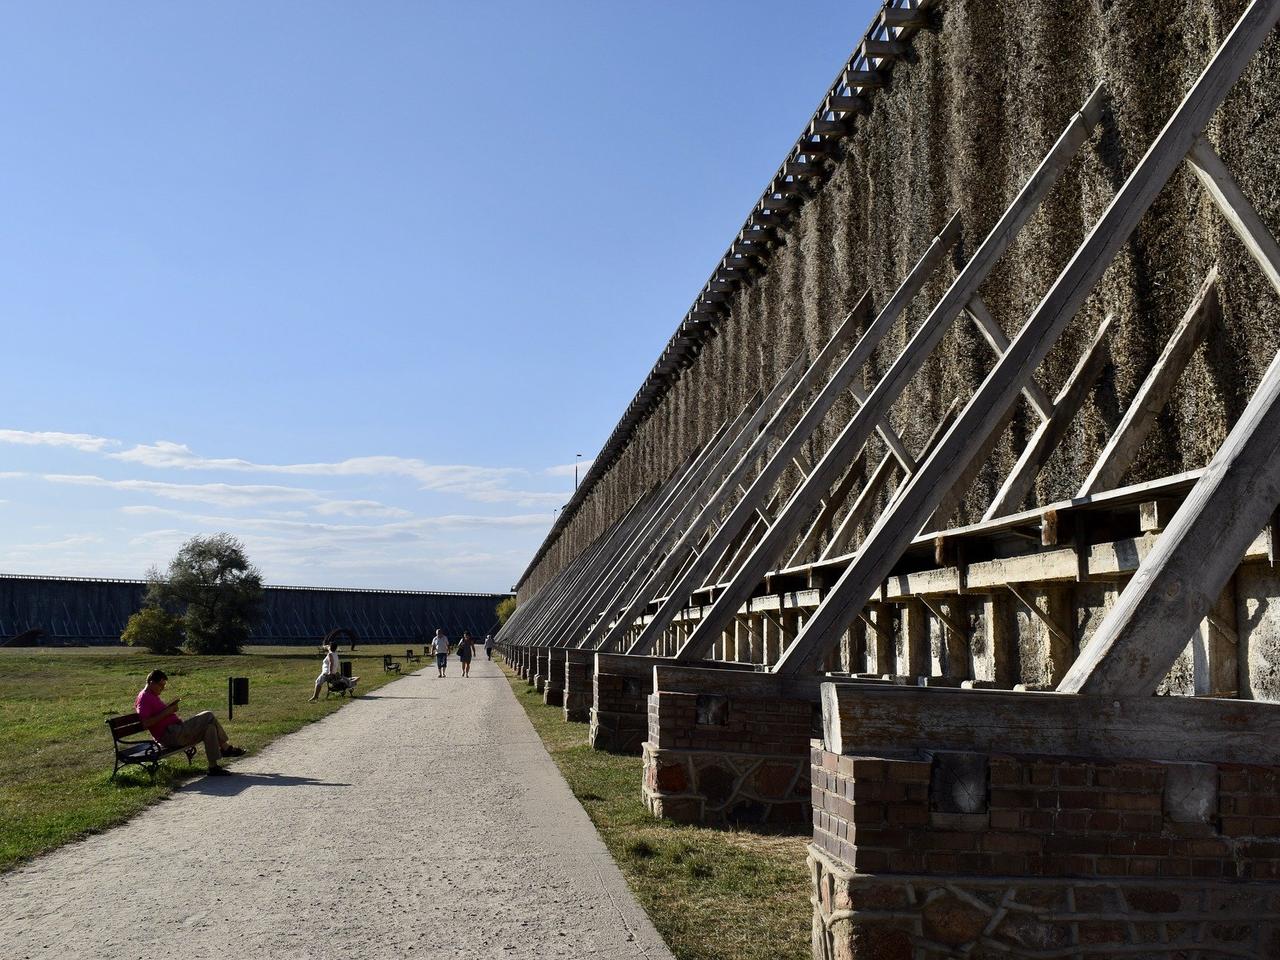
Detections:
[518, 0, 1280, 602]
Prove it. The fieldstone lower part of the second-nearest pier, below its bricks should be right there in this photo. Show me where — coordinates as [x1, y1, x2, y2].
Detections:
[644, 742, 810, 824]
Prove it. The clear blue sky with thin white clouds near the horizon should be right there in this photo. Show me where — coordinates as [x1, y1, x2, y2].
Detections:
[0, 0, 874, 590]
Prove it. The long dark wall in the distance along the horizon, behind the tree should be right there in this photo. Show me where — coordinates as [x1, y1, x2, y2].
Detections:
[0, 576, 508, 645]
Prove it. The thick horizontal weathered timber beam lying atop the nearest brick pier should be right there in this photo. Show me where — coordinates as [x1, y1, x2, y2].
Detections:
[820, 682, 1280, 764]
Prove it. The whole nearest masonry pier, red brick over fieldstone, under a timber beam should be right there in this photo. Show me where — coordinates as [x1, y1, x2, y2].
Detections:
[809, 749, 1280, 960]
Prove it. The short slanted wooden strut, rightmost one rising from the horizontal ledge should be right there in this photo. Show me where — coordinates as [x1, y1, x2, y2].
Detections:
[1078, 266, 1221, 497]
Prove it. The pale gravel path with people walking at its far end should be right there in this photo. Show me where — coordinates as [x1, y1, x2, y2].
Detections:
[0, 657, 671, 960]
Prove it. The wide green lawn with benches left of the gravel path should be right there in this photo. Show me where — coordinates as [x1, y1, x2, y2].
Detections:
[0, 645, 404, 870]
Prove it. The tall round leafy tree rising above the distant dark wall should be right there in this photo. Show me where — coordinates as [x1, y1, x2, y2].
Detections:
[147, 534, 262, 653]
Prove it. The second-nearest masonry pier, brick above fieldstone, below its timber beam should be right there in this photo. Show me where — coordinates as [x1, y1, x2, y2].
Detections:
[644, 690, 815, 823]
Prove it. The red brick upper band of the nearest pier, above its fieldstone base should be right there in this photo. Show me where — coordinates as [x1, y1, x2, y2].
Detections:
[812, 750, 1280, 881]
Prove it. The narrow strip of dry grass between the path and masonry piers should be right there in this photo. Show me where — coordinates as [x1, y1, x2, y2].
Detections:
[504, 667, 813, 960]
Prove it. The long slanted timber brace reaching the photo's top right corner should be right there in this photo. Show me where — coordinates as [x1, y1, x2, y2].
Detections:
[777, 0, 1280, 686]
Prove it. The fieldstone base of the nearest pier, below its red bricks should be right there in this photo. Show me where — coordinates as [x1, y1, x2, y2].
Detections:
[808, 845, 1280, 960]
